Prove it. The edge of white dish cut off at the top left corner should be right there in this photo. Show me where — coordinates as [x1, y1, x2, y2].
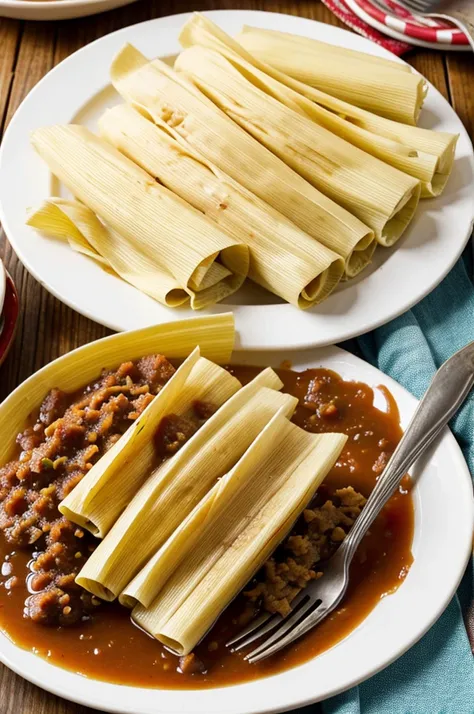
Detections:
[0, 0, 135, 20]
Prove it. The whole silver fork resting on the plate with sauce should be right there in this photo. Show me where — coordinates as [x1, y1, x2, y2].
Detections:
[227, 342, 474, 663]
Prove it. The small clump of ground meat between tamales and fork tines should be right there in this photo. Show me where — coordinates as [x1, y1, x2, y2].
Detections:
[244, 486, 366, 616]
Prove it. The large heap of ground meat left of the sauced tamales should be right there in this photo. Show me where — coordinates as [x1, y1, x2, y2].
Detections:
[0, 355, 196, 625]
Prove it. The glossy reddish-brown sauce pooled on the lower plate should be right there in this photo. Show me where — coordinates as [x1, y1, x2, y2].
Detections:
[0, 366, 414, 689]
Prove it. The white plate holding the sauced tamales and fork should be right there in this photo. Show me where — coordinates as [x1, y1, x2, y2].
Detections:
[0, 338, 473, 714]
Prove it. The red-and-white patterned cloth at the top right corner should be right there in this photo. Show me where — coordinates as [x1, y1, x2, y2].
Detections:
[323, 0, 469, 55]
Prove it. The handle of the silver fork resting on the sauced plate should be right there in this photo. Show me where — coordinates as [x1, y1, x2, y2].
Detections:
[337, 342, 474, 567]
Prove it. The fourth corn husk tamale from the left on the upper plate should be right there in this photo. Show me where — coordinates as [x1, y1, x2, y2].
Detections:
[175, 46, 420, 246]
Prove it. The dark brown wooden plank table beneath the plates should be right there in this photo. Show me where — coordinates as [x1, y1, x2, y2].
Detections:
[0, 0, 474, 714]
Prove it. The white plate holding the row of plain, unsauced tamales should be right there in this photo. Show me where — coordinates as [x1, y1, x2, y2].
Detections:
[0, 11, 474, 349]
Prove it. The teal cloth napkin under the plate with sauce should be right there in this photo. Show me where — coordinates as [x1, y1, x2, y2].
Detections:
[292, 251, 474, 714]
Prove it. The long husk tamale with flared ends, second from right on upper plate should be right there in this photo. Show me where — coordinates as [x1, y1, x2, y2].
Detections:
[179, 13, 458, 198]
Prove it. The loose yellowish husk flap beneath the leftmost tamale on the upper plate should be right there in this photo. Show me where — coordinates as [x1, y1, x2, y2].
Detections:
[26, 198, 189, 307]
